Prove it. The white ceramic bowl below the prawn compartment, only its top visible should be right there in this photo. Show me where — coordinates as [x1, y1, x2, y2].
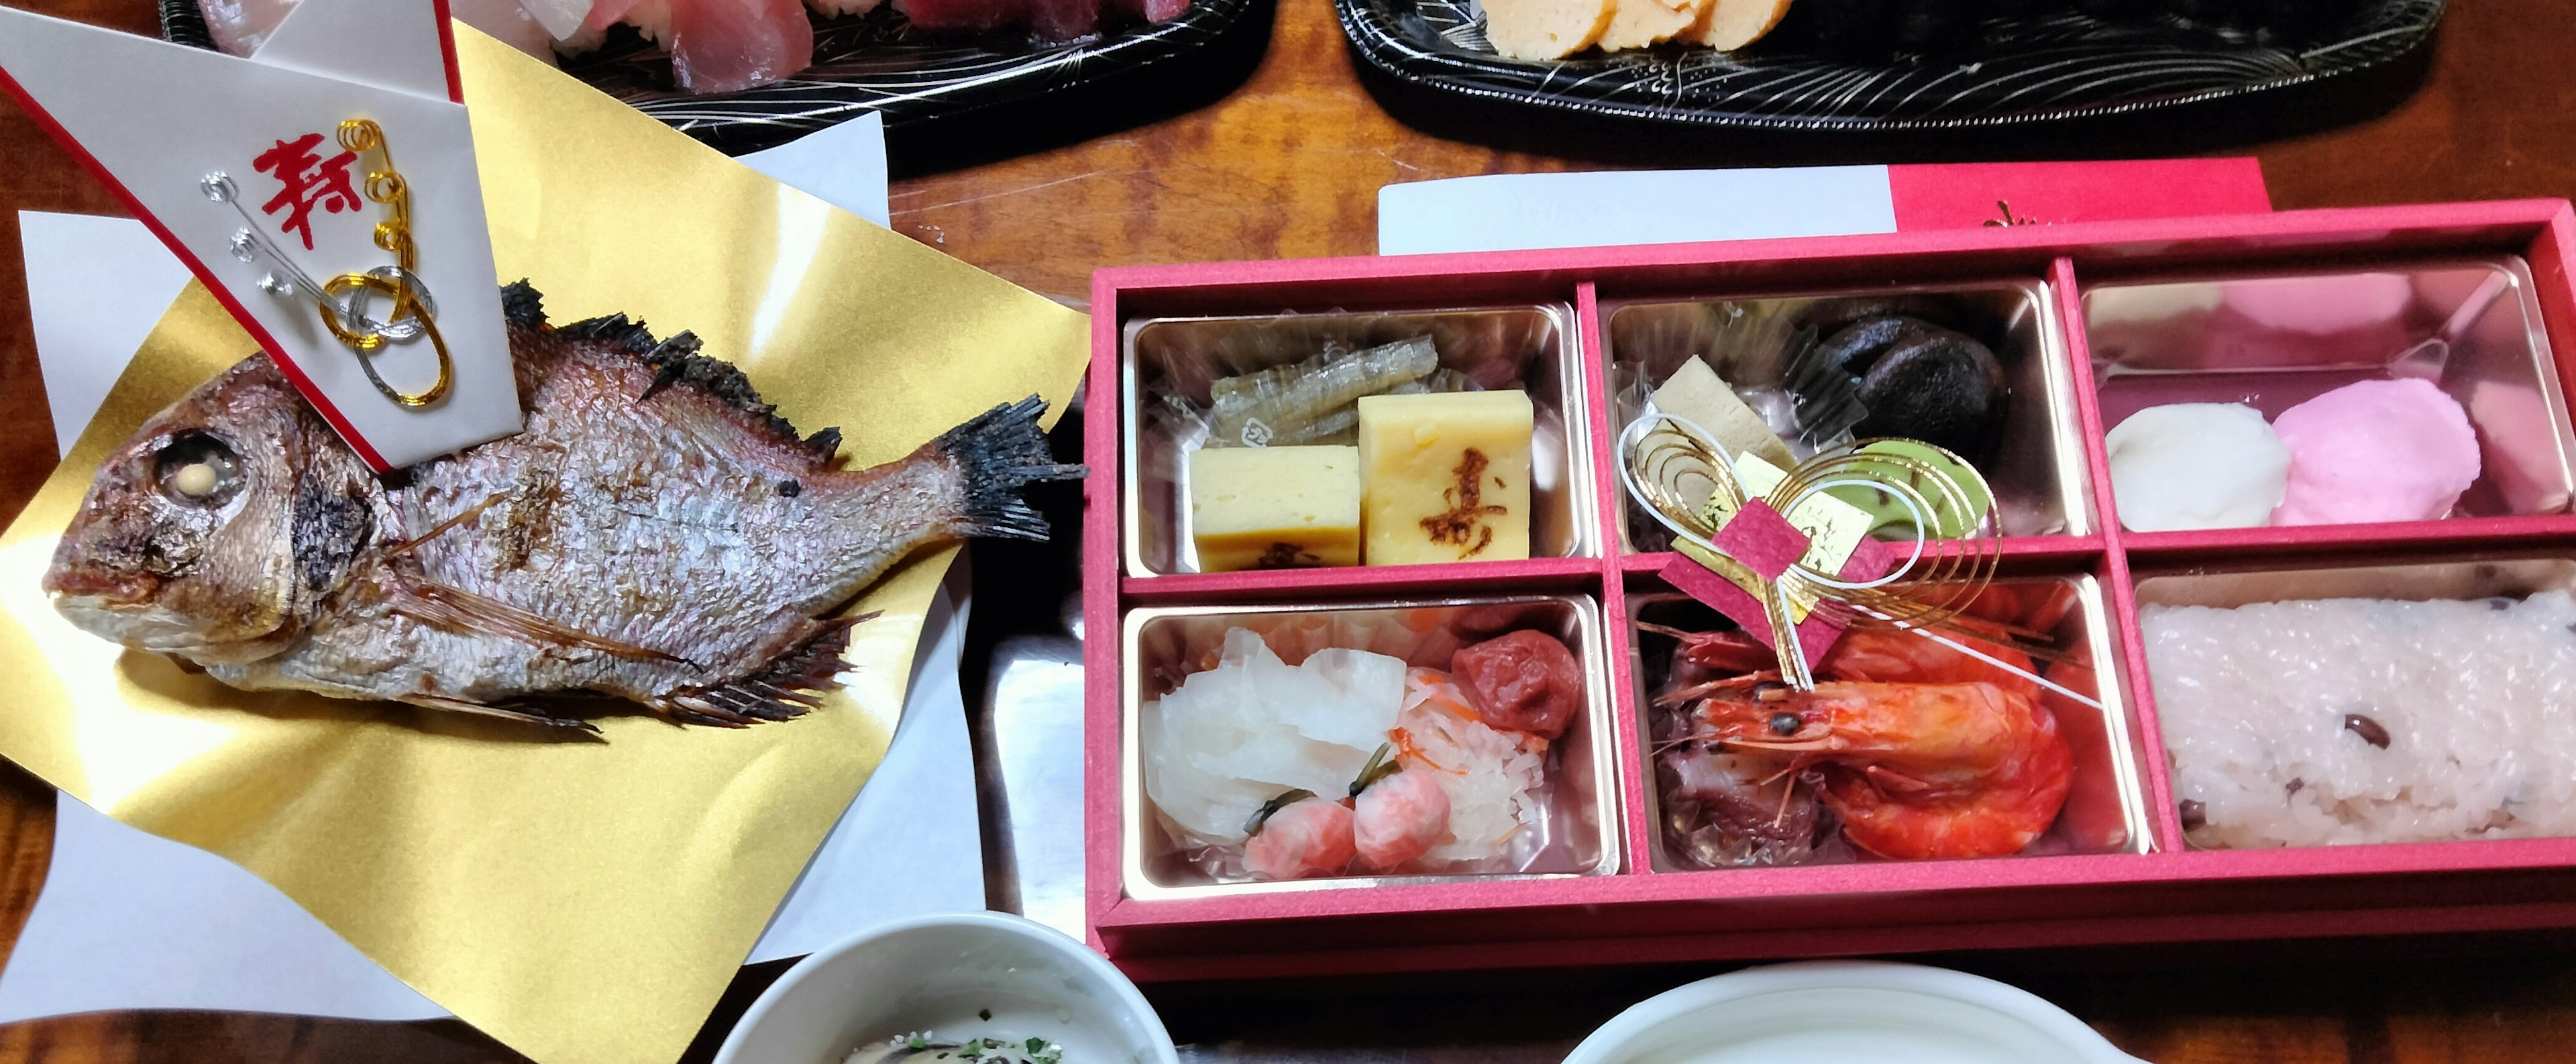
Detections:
[1566, 961, 2141, 1064]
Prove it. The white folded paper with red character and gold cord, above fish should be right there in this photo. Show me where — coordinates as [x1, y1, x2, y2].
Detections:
[0, 0, 521, 469]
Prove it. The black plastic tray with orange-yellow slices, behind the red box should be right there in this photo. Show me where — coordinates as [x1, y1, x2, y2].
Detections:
[1334, 0, 2445, 131]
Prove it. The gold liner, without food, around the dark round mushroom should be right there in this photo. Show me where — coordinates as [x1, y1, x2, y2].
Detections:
[1602, 278, 2092, 549]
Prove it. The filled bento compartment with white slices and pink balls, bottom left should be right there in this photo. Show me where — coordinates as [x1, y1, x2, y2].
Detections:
[1120, 595, 1620, 899]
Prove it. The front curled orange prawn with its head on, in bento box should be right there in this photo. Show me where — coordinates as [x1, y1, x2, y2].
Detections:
[1677, 675, 2074, 861]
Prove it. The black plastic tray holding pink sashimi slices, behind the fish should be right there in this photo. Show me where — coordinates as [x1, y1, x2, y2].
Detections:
[160, 0, 1270, 154]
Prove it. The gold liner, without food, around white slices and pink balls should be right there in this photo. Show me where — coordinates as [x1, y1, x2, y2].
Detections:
[1118, 595, 1623, 899]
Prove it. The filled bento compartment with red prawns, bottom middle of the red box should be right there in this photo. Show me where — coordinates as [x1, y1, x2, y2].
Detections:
[1623, 574, 2153, 871]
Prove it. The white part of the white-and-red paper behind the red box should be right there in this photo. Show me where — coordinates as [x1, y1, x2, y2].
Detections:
[1378, 165, 1896, 255]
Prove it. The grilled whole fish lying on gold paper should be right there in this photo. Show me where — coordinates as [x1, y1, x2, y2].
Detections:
[44, 283, 1082, 727]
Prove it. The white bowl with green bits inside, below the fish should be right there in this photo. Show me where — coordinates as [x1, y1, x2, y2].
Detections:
[716, 912, 1177, 1064]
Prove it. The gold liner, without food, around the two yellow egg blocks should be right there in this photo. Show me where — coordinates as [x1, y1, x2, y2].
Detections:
[1118, 304, 1600, 577]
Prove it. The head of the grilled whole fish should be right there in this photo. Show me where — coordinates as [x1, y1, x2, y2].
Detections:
[44, 358, 366, 665]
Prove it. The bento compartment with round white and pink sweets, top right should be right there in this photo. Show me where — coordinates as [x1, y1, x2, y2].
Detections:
[2084, 255, 2576, 546]
